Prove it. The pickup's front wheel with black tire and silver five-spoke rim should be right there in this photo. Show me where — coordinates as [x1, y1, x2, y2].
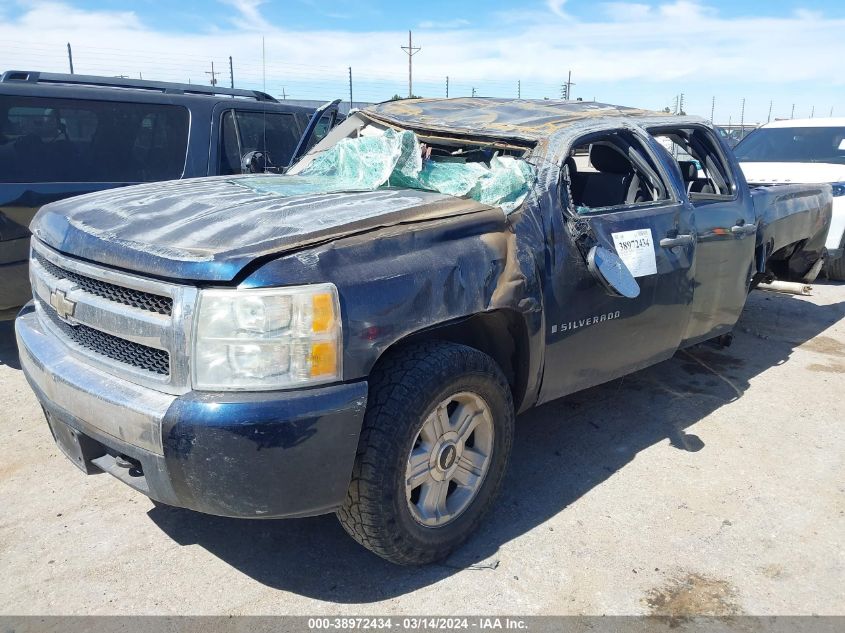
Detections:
[337, 341, 514, 565]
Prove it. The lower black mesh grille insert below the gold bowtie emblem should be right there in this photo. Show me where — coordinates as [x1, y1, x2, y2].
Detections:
[38, 299, 170, 376]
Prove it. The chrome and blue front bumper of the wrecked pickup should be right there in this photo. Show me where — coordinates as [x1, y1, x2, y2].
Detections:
[15, 307, 367, 518]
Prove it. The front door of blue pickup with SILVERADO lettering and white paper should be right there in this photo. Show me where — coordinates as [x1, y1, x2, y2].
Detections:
[540, 129, 696, 401]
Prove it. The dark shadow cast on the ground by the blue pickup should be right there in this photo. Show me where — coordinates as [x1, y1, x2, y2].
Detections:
[149, 284, 845, 603]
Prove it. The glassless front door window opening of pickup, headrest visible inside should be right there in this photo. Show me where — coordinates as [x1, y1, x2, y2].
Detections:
[563, 132, 670, 214]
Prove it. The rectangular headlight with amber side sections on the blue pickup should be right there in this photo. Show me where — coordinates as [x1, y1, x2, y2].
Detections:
[192, 284, 343, 390]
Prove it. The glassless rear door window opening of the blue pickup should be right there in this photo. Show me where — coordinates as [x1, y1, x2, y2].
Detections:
[654, 128, 735, 204]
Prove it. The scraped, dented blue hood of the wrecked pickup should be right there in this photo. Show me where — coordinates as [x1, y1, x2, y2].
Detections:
[30, 175, 490, 282]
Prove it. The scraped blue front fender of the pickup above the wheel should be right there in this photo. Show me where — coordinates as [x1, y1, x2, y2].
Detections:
[242, 209, 542, 388]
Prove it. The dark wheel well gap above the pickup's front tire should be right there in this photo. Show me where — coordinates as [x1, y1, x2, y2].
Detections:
[382, 310, 529, 411]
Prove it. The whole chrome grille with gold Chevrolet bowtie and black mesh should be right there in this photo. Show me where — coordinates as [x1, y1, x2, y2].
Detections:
[29, 238, 198, 395]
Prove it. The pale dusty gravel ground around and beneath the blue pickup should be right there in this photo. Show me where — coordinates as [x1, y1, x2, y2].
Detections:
[0, 283, 845, 615]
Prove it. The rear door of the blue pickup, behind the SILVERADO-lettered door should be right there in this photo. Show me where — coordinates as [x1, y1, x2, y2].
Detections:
[649, 124, 757, 345]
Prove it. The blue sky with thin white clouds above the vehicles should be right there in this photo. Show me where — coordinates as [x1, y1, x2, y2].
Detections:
[0, 0, 845, 124]
